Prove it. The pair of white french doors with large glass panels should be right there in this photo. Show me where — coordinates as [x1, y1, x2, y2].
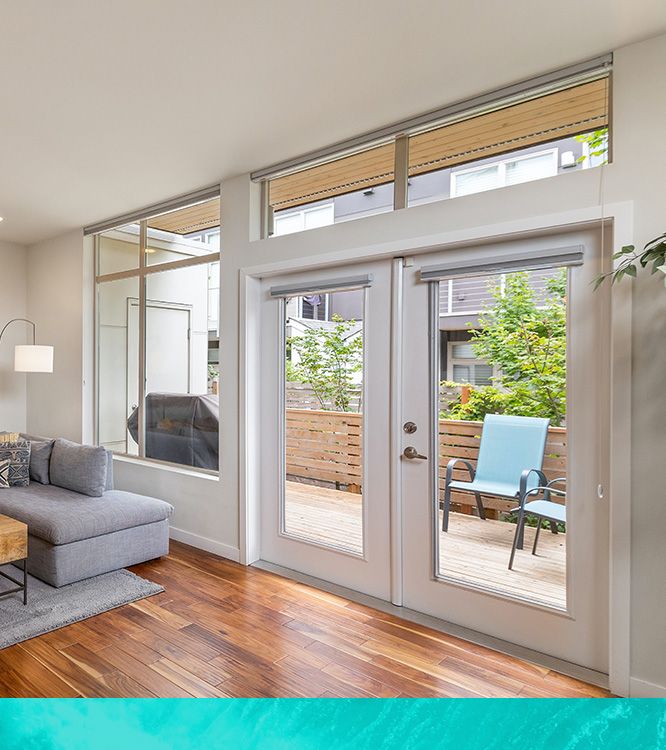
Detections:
[261, 230, 608, 672]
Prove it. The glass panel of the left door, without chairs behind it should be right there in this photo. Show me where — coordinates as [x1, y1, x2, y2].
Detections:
[281, 290, 365, 555]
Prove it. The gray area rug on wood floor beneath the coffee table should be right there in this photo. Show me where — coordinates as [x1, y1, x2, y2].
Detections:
[0, 565, 164, 649]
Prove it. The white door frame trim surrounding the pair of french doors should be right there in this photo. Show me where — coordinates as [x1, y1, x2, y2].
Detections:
[238, 201, 634, 695]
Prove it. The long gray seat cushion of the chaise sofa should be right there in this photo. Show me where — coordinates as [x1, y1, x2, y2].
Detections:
[0, 484, 173, 544]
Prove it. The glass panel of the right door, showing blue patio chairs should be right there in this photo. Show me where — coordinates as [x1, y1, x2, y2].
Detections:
[436, 269, 568, 609]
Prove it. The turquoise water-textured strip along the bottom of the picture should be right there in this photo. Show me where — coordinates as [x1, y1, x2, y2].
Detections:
[0, 699, 666, 750]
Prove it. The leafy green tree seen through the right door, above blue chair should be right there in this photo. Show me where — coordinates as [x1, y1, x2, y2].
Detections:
[464, 270, 566, 425]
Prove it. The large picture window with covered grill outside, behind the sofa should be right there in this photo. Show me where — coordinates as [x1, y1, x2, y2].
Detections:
[96, 198, 220, 472]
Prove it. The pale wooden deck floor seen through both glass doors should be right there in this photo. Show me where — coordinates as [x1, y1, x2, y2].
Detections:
[285, 482, 566, 609]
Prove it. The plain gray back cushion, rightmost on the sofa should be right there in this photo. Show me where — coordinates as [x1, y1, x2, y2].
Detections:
[50, 438, 108, 497]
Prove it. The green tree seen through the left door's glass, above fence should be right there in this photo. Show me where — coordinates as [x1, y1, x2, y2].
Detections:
[288, 315, 363, 411]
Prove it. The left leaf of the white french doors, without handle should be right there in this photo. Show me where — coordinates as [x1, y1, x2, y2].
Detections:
[261, 261, 391, 599]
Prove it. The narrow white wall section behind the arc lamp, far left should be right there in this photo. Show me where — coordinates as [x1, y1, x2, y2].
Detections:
[0, 242, 27, 432]
